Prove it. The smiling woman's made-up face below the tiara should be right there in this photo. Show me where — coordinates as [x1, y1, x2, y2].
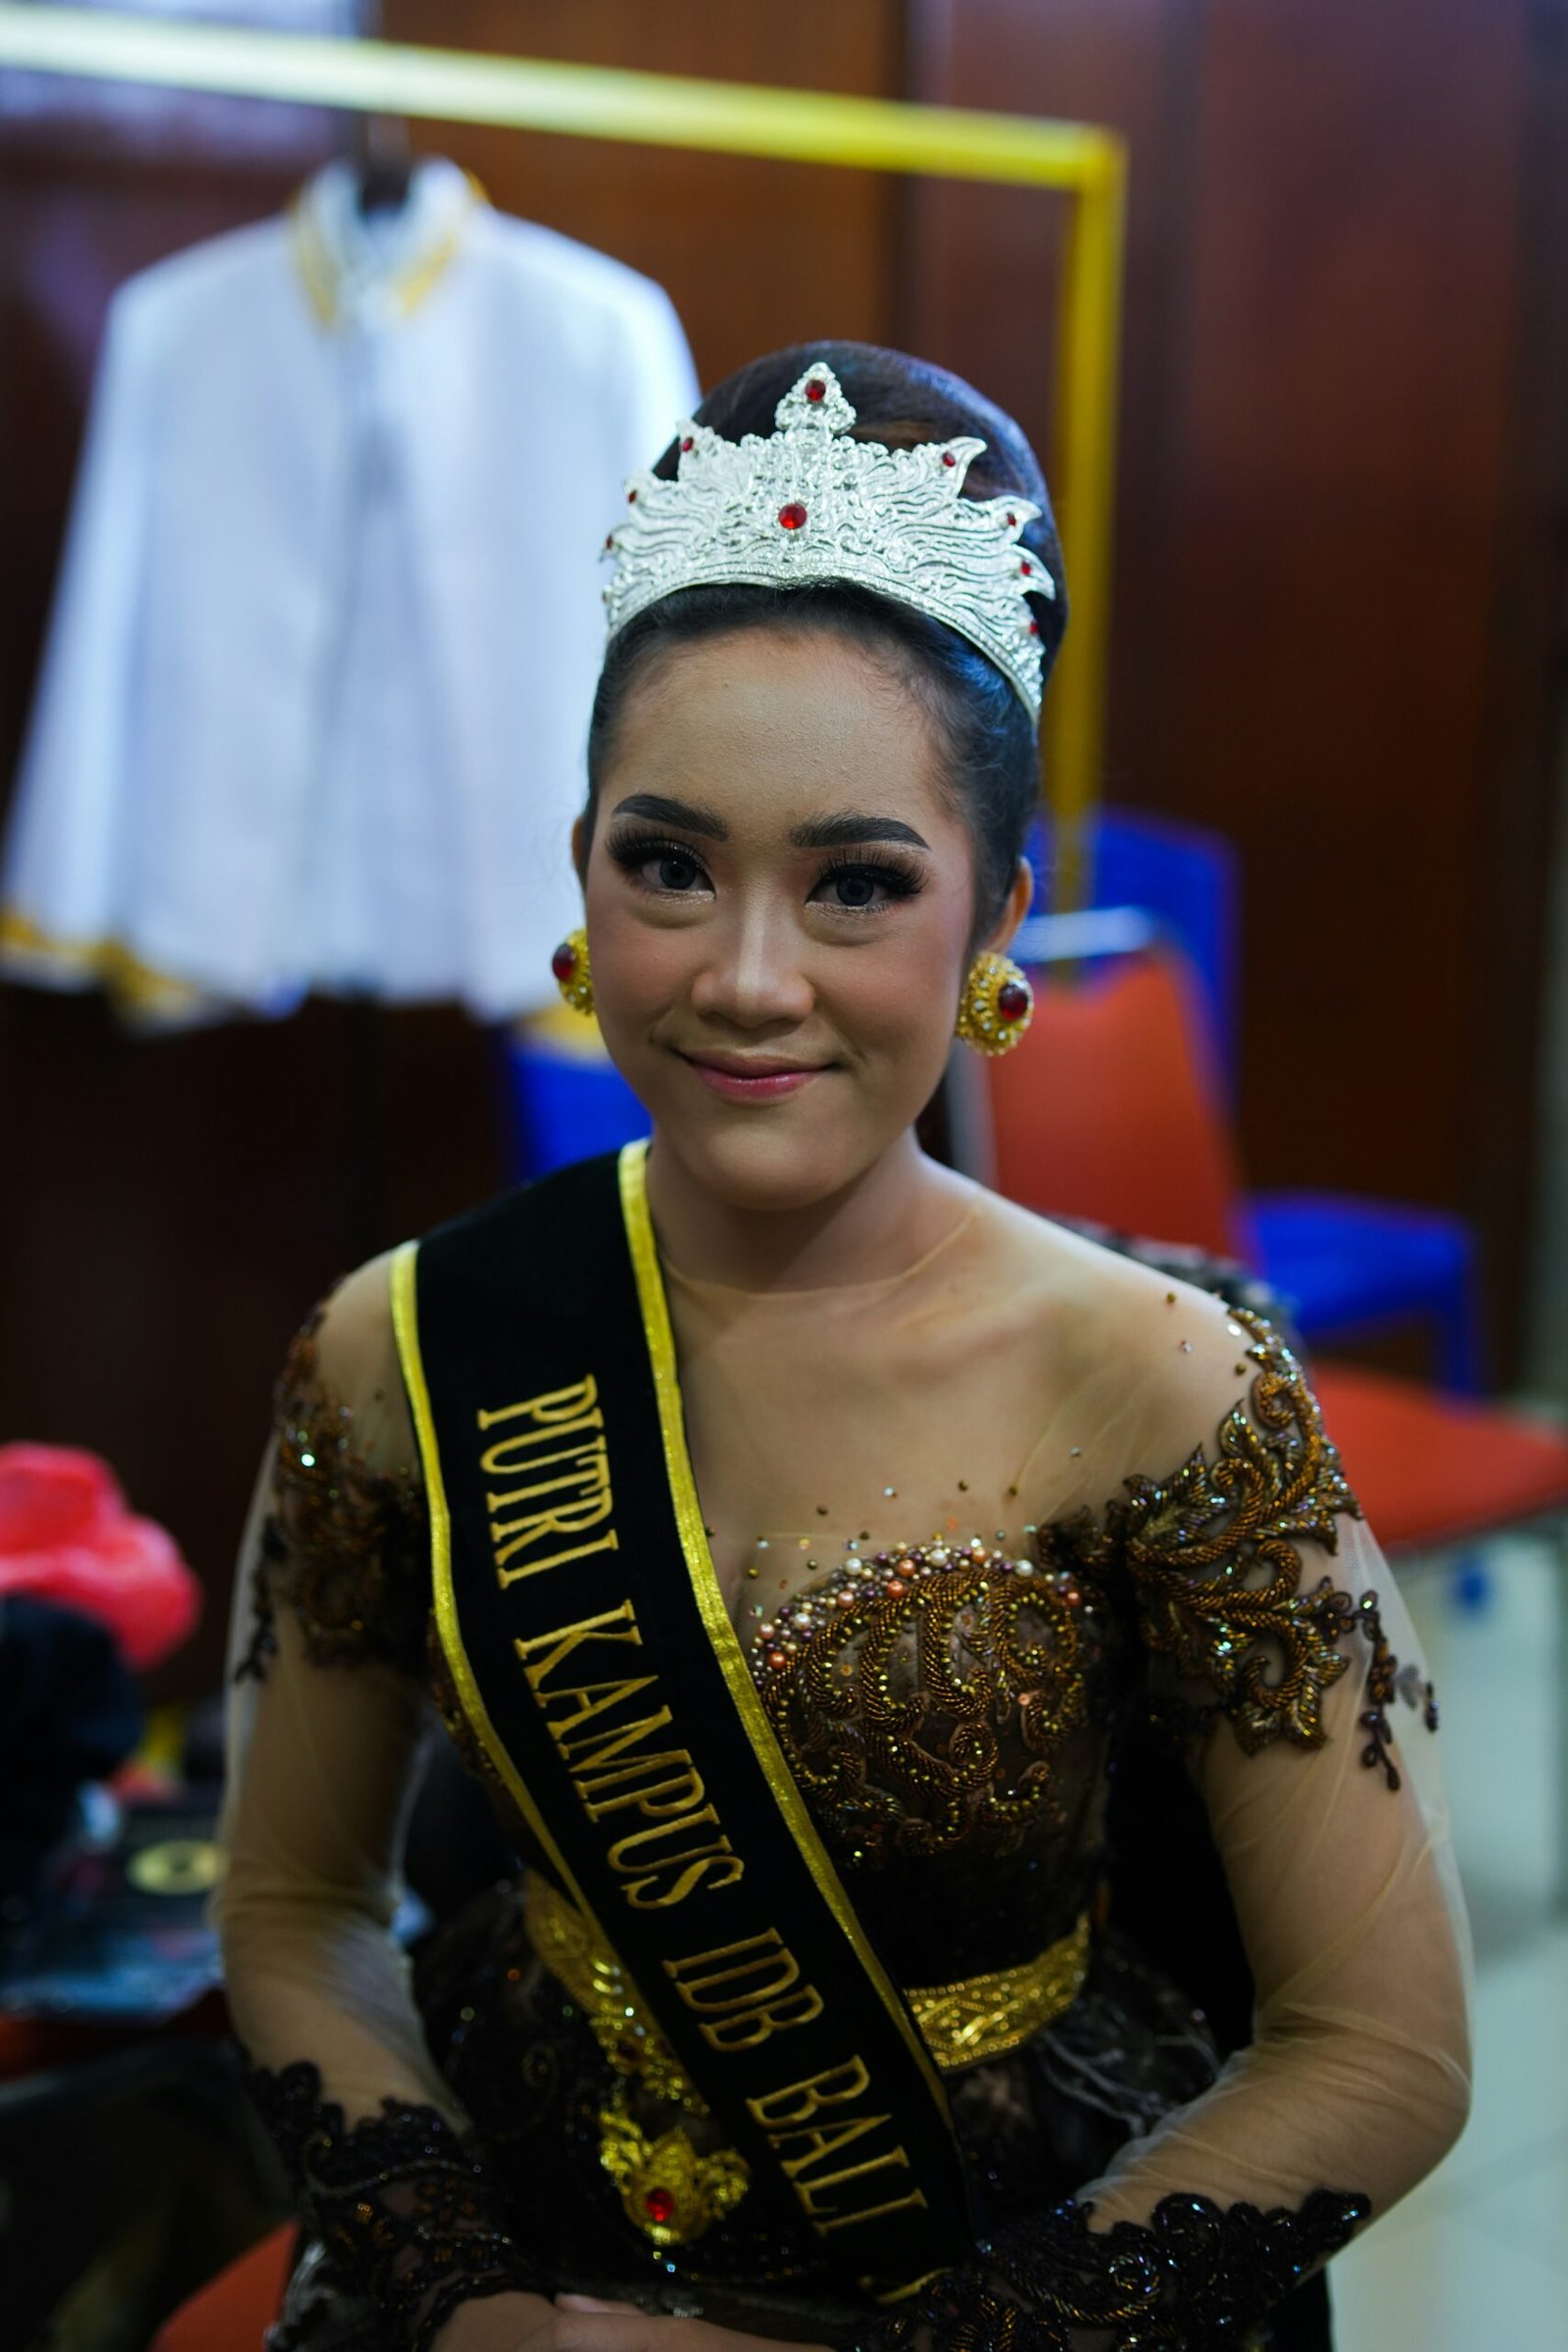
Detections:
[583, 628, 1010, 1209]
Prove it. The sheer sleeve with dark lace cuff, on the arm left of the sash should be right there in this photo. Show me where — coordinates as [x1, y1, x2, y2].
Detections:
[217, 1263, 536, 2352]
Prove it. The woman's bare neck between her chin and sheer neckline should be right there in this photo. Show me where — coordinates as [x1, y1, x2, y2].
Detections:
[649, 1131, 971, 1292]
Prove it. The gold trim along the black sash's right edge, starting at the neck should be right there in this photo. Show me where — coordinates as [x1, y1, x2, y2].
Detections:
[620, 1141, 953, 2129]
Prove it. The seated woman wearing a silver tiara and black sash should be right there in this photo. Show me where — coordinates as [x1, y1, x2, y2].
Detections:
[223, 343, 1467, 2352]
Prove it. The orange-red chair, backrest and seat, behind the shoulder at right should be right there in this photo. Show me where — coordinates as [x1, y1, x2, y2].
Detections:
[985, 951, 1568, 1550]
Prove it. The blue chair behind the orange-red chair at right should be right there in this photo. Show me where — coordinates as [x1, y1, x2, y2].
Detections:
[1030, 809, 1486, 1395]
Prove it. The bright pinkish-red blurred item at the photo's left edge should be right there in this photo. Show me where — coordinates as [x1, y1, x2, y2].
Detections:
[0, 1445, 202, 1670]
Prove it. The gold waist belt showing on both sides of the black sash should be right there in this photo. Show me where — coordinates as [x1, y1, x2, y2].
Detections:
[524, 1870, 1089, 2107]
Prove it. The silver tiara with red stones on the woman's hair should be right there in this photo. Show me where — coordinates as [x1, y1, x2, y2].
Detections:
[604, 360, 1055, 719]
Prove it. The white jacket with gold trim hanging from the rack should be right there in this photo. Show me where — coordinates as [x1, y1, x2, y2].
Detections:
[0, 163, 696, 1021]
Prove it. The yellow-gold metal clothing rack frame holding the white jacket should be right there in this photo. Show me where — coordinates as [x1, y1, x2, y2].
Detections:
[0, 5, 1126, 907]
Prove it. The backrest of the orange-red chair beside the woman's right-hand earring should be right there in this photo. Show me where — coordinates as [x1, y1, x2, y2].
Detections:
[987, 948, 1253, 1263]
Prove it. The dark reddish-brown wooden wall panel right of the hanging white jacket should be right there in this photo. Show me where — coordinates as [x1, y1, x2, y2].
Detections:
[909, 0, 1568, 1364]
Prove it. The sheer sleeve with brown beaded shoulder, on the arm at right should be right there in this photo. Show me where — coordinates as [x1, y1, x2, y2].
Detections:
[870, 1294, 1469, 2352]
